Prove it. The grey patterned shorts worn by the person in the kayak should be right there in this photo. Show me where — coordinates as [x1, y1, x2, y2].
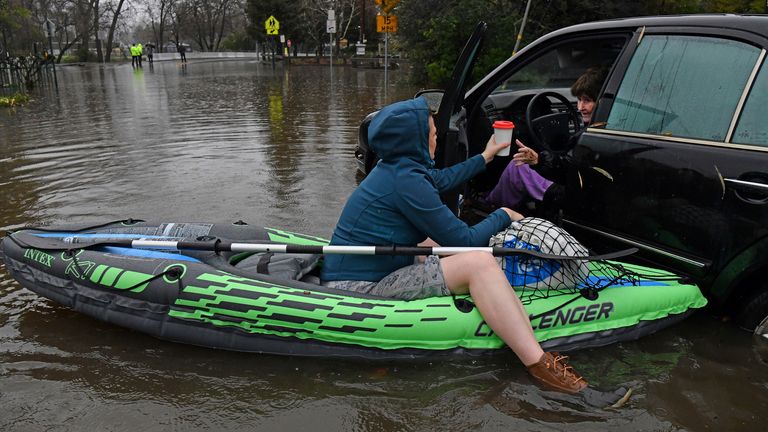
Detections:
[324, 255, 451, 300]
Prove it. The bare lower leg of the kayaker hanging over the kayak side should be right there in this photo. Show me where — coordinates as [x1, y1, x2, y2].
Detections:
[440, 252, 544, 366]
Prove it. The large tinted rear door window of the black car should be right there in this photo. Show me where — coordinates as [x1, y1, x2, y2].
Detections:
[606, 35, 760, 141]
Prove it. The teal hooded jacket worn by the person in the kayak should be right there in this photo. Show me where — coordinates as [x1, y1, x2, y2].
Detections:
[321, 98, 512, 282]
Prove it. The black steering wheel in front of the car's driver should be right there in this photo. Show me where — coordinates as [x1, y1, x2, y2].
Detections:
[525, 91, 583, 151]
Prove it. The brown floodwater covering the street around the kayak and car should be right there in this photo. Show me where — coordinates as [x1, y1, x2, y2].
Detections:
[0, 61, 768, 431]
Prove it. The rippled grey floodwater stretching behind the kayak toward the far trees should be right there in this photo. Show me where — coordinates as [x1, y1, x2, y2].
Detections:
[0, 62, 413, 234]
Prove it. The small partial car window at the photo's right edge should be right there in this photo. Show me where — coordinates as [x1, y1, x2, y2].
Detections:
[732, 59, 768, 147]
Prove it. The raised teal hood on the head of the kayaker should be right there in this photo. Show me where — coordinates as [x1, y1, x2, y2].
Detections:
[368, 97, 435, 168]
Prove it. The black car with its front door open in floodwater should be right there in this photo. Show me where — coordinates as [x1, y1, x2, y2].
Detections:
[355, 15, 768, 333]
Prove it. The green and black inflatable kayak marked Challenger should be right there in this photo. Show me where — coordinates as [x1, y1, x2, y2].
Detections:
[0, 220, 706, 359]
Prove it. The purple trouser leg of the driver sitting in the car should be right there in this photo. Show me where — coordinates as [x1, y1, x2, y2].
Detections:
[486, 161, 552, 207]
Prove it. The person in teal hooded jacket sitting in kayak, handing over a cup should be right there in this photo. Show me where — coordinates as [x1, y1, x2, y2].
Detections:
[321, 98, 587, 393]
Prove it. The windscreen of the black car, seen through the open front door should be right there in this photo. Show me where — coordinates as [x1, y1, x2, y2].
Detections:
[493, 37, 626, 93]
